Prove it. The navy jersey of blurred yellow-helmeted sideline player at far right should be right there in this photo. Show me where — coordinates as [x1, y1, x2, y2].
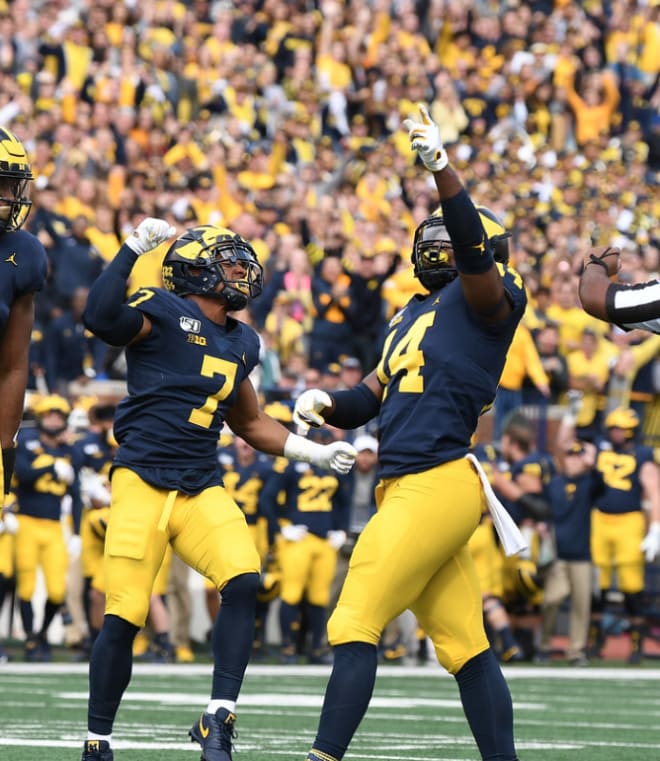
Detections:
[595, 441, 654, 515]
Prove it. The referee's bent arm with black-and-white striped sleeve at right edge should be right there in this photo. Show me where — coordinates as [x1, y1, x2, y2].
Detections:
[579, 246, 660, 333]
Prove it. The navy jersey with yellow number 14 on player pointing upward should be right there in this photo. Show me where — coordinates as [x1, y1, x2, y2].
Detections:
[377, 265, 527, 478]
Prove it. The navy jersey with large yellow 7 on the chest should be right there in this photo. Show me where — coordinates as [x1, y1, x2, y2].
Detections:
[114, 288, 259, 494]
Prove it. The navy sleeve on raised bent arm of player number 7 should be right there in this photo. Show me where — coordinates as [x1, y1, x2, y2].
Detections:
[83, 245, 144, 346]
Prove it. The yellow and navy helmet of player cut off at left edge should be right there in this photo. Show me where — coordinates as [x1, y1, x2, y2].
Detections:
[0, 127, 34, 233]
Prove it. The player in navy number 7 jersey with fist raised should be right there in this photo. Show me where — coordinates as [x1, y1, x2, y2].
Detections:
[82, 217, 355, 761]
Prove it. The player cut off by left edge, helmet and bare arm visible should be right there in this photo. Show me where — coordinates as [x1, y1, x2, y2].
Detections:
[0, 127, 48, 502]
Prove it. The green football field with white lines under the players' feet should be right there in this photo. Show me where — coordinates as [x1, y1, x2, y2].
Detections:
[0, 663, 660, 761]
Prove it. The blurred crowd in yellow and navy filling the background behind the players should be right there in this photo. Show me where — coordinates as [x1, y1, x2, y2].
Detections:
[0, 0, 660, 664]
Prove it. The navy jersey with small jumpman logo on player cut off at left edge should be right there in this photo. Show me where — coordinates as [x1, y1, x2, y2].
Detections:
[0, 230, 48, 332]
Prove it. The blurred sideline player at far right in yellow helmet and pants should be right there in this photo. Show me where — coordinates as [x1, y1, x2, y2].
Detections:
[591, 407, 660, 664]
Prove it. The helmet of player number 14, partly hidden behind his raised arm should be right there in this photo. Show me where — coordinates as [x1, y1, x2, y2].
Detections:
[411, 206, 511, 291]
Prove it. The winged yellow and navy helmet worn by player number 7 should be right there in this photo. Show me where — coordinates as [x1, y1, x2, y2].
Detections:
[163, 225, 263, 311]
